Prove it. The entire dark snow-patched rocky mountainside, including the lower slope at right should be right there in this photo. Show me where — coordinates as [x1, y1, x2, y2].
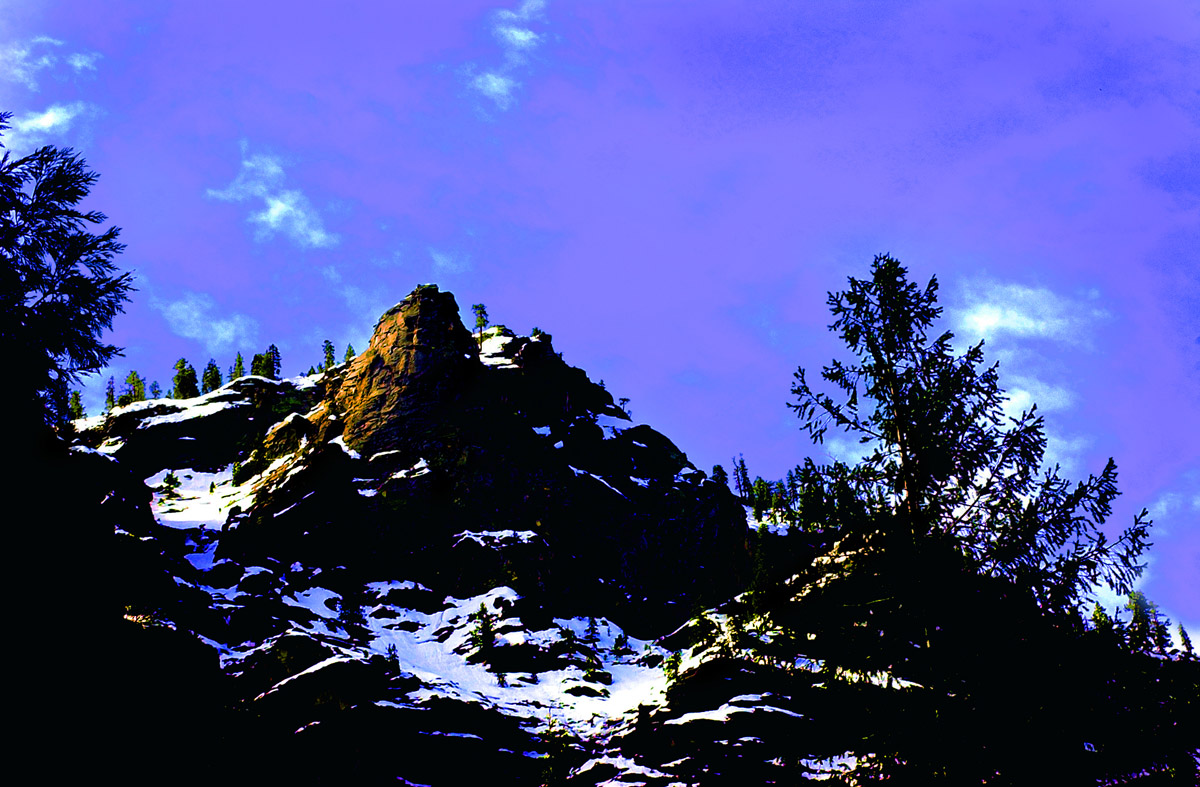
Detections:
[42, 280, 1200, 786]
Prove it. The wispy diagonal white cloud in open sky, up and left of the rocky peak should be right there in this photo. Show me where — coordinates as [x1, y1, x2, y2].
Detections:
[208, 142, 340, 248]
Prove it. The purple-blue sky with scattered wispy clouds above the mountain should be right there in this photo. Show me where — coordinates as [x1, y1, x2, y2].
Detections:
[0, 0, 1200, 636]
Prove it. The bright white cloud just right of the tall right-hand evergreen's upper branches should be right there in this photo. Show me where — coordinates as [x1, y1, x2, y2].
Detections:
[955, 282, 1108, 346]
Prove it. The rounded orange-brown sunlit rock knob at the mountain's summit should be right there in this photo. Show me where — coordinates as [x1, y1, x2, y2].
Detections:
[336, 284, 478, 456]
